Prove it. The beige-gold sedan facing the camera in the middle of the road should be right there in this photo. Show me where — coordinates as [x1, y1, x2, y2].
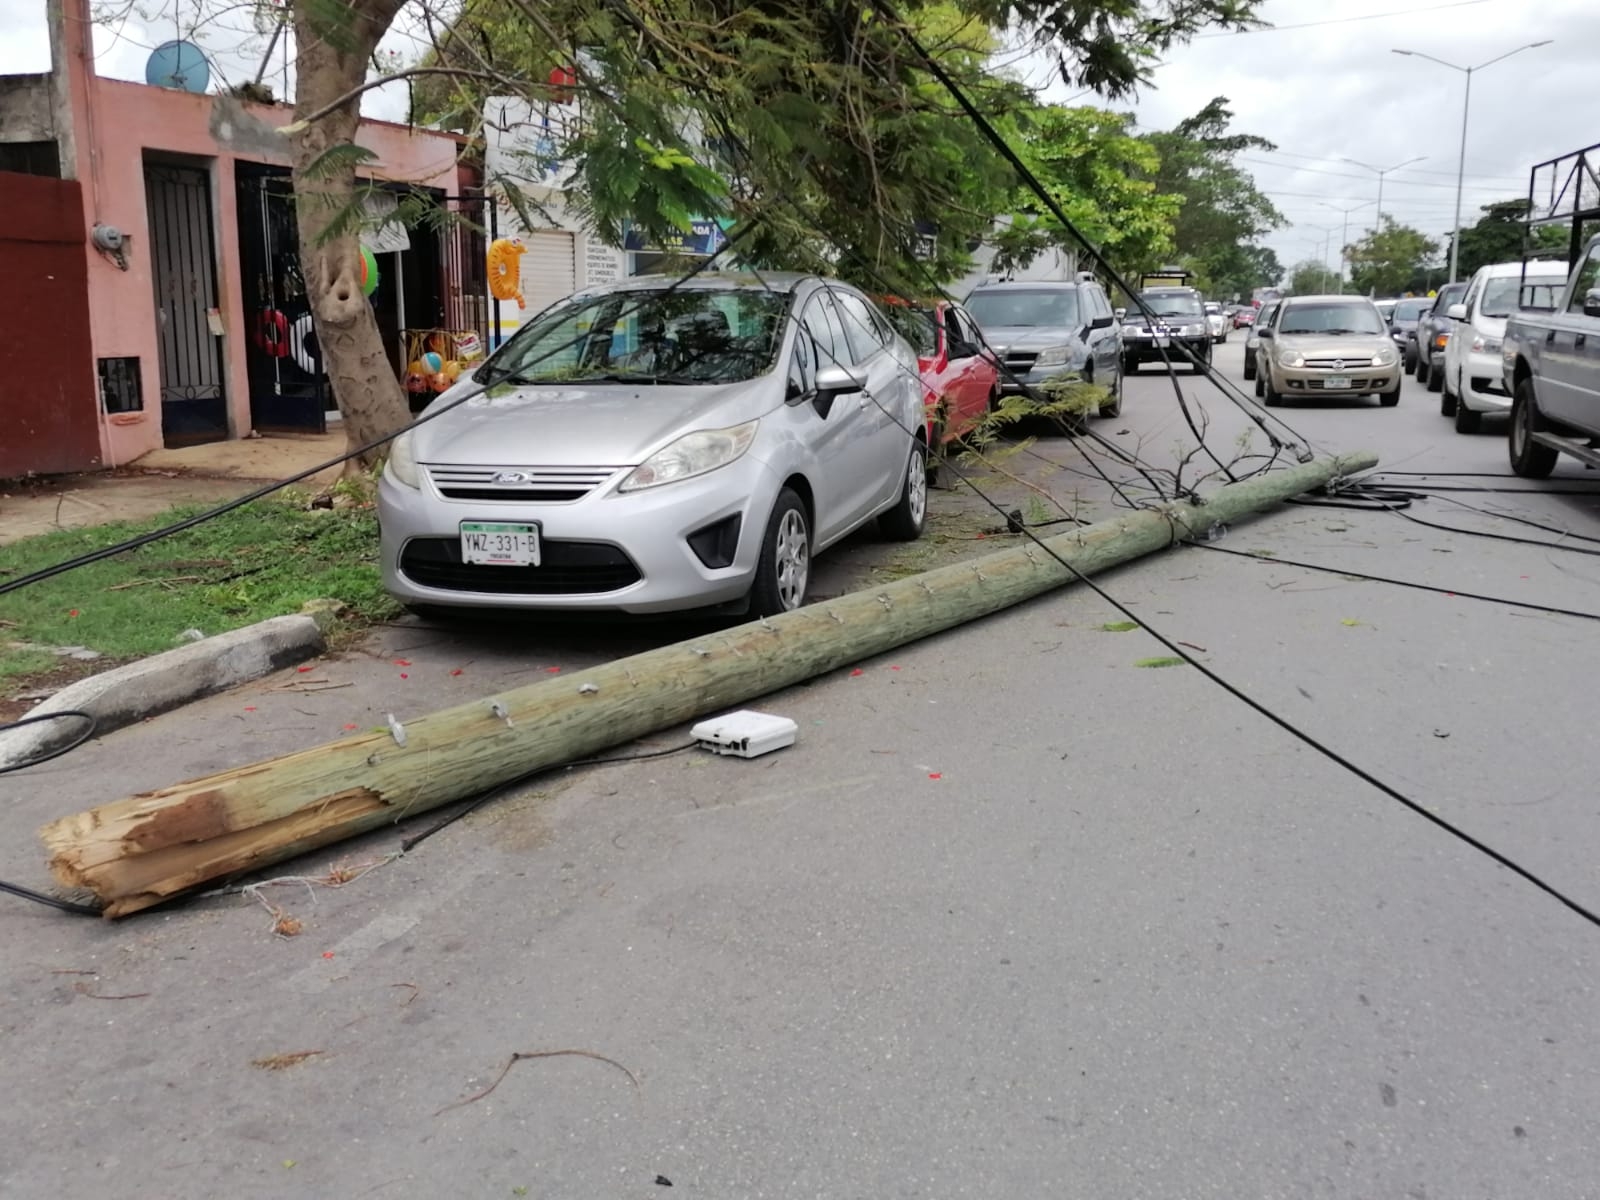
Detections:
[1256, 296, 1403, 408]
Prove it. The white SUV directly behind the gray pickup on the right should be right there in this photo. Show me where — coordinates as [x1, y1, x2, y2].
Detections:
[1438, 262, 1566, 434]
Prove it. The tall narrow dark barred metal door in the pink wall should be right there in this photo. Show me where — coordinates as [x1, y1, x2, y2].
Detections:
[144, 163, 227, 446]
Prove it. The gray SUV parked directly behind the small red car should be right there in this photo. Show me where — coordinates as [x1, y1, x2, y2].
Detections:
[966, 275, 1122, 416]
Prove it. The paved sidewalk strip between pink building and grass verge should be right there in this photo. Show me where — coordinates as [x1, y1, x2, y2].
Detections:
[0, 429, 344, 546]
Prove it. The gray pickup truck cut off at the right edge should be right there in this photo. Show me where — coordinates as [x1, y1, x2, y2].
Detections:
[1502, 237, 1600, 478]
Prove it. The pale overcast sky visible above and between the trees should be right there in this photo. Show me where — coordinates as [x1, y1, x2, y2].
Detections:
[0, 0, 1600, 281]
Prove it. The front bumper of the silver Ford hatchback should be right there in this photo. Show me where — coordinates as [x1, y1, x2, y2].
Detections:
[378, 454, 782, 613]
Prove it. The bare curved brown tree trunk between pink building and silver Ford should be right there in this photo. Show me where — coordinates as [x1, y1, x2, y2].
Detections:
[293, 0, 411, 467]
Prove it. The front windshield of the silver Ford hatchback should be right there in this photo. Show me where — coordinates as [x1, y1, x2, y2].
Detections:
[478, 288, 789, 384]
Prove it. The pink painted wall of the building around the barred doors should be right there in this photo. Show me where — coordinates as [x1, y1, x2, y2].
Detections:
[66, 0, 459, 466]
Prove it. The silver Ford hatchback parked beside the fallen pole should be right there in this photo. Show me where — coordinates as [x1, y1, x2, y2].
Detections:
[378, 275, 928, 614]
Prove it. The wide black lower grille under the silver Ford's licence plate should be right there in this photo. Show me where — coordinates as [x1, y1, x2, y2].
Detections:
[400, 538, 643, 595]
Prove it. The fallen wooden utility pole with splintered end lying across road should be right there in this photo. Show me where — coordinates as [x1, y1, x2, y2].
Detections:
[40, 454, 1378, 917]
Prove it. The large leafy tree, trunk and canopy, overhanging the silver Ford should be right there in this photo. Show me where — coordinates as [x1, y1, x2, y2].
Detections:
[291, 0, 1259, 460]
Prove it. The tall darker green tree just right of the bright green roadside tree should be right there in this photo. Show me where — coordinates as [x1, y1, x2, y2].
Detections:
[1144, 96, 1283, 296]
